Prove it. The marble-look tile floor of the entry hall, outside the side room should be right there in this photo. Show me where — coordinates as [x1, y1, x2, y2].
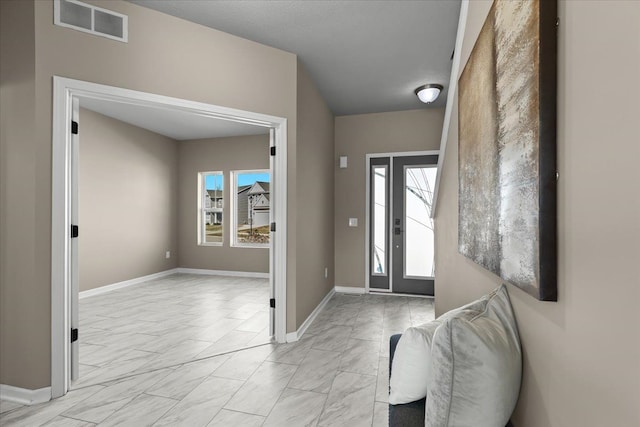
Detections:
[0, 294, 434, 427]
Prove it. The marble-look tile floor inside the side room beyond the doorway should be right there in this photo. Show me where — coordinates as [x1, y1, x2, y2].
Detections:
[72, 274, 271, 388]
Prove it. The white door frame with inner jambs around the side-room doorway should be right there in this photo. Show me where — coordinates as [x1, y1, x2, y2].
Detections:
[51, 77, 287, 398]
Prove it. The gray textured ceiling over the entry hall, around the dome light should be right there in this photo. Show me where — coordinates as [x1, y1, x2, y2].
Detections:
[130, 0, 460, 115]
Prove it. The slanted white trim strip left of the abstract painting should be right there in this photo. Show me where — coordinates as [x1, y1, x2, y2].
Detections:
[431, 0, 469, 218]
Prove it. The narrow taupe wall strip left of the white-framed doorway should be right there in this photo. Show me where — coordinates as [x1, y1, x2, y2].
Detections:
[0, 1, 40, 389]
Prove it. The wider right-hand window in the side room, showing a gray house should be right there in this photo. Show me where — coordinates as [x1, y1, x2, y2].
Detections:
[231, 169, 271, 247]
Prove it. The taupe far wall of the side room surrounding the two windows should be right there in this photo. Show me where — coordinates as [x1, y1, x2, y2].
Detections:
[178, 135, 269, 273]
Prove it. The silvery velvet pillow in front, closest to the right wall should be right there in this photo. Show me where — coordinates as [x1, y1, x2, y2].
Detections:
[425, 285, 522, 427]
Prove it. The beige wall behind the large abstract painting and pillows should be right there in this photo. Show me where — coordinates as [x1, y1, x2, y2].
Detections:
[435, 1, 640, 427]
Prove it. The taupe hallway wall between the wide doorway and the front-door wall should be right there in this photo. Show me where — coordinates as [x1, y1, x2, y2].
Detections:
[296, 62, 334, 329]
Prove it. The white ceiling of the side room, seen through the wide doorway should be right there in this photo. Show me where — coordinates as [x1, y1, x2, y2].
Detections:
[80, 98, 269, 141]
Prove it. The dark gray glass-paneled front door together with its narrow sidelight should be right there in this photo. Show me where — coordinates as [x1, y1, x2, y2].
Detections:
[369, 155, 438, 295]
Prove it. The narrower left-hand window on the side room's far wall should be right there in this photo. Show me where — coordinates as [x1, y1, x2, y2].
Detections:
[198, 172, 224, 246]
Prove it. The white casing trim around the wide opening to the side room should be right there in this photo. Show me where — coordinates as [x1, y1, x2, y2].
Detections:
[51, 76, 287, 398]
